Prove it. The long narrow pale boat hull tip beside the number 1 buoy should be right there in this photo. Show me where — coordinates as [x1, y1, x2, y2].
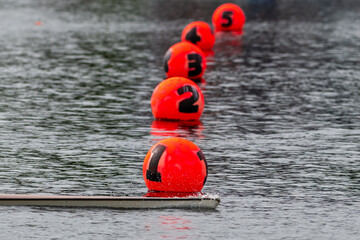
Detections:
[0, 194, 220, 209]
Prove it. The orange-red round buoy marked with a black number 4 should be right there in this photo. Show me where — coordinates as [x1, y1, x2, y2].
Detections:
[181, 21, 215, 52]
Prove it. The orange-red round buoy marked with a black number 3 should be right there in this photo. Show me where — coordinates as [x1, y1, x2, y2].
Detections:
[164, 42, 206, 80]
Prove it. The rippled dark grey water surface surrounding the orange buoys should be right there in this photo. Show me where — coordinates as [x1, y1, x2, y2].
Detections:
[0, 0, 360, 239]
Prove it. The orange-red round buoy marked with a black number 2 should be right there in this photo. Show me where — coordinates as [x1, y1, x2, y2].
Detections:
[151, 77, 204, 120]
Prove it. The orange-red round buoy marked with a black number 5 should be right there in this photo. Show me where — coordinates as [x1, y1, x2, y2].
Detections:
[212, 3, 246, 31]
